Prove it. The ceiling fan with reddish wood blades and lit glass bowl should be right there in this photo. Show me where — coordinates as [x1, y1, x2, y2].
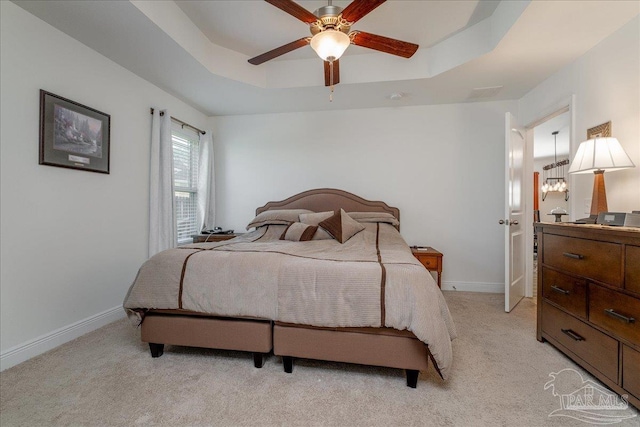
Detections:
[249, 0, 418, 87]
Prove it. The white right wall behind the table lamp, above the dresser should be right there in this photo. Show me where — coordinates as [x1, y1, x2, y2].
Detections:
[519, 17, 640, 219]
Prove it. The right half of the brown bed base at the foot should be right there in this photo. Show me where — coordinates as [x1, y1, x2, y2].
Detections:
[273, 322, 429, 388]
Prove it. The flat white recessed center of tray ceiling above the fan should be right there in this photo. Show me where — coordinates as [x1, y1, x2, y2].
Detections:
[176, 0, 500, 60]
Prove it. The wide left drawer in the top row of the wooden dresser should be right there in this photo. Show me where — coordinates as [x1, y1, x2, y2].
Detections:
[543, 234, 622, 287]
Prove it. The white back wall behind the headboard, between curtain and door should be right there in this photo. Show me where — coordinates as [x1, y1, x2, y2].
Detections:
[212, 101, 516, 291]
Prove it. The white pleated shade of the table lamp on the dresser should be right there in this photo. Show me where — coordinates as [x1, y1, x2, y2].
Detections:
[569, 138, 636, 173]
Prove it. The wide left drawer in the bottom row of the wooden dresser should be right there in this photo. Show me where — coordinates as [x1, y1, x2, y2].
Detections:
[542, 302, 618, 383]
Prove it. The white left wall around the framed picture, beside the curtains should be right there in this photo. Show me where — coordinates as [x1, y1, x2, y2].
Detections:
[0, 1, 208, 369]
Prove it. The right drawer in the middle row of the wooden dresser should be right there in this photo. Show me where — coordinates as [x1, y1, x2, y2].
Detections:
[589, 284, 640, 344]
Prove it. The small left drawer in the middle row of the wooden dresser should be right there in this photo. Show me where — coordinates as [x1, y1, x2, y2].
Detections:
[542, 268, 587, 319]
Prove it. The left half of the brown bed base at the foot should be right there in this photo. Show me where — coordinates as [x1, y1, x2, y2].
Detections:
[141, 312, 273, 368]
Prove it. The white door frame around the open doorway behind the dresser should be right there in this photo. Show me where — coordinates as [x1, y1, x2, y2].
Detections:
[524, 95, 581, 298]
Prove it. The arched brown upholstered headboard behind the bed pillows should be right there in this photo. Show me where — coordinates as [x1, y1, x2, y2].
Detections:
[256, 188, 400, 230]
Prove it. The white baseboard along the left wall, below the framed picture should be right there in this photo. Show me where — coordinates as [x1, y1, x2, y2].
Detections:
[0, 306, 125, 371]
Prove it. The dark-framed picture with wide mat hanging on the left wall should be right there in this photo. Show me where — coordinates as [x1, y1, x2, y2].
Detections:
[40, 89, 111, 173]
